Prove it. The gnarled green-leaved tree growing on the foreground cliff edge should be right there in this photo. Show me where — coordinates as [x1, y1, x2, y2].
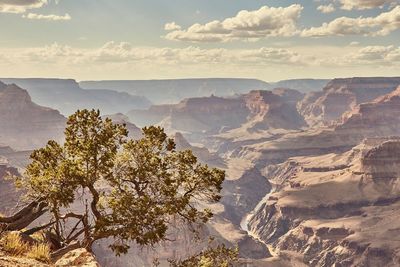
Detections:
[7, 110, 225, 262]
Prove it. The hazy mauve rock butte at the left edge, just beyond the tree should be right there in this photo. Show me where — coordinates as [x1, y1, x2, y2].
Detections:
[0, 84, 66, 150]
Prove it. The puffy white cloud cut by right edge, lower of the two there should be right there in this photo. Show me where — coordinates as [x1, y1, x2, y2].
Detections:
[301, 6, 400, 37]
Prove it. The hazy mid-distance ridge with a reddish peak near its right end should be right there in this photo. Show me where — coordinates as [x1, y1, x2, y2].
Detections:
[128, 89, 306, 134]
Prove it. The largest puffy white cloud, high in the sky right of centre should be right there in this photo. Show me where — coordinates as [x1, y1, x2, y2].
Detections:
[166, 4, 303, 42]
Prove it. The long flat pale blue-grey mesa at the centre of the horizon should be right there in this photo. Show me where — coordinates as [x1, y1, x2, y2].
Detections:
[79, 78, 269, 104]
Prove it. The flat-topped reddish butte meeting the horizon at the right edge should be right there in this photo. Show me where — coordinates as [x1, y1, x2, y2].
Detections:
[299, 78, 400, 125]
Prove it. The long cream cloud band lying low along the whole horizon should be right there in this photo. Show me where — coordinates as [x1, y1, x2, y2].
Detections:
[0, 42, 400, 80]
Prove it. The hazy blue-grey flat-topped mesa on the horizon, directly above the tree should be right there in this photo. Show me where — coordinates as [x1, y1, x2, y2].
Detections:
[0, 78, 151, 116]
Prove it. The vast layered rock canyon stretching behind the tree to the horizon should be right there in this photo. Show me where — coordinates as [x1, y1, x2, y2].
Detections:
[0, 77, 400, 266]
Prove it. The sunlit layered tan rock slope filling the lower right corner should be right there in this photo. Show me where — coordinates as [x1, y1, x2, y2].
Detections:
[250, 138, 400, 266]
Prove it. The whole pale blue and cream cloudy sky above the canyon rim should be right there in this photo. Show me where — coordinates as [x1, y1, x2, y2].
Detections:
[0, 0, 400, 82]
